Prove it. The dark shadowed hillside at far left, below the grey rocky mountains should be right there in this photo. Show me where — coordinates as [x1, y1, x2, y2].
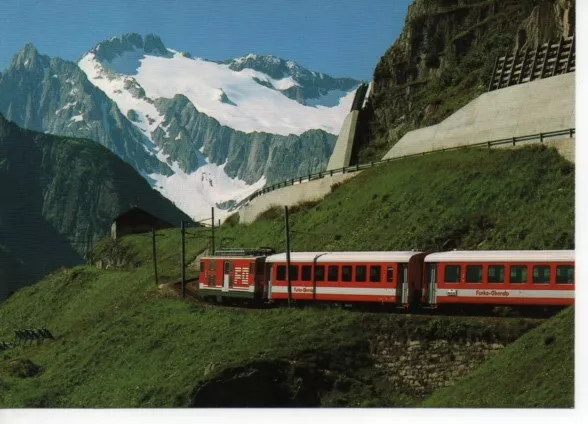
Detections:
[0, 115, 188, 301]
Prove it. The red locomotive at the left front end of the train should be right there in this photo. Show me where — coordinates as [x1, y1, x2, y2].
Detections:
[199, 249, 273, 300]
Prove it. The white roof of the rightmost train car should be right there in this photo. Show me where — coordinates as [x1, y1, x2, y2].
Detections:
[425, 250, 575, 262]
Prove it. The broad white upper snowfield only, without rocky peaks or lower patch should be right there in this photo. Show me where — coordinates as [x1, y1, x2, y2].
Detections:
[78, 49, 354, 136]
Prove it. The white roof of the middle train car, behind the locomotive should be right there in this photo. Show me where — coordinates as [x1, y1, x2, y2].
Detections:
[266, 251, 421, 263]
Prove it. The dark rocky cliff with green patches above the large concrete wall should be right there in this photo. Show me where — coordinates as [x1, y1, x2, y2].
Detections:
[359, 0, 575, 161]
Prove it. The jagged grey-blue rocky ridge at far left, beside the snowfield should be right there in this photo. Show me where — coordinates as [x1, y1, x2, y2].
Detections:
[0, 43, 171, 174]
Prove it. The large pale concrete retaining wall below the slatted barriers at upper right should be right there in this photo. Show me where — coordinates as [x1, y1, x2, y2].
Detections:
[384, 73, 576, 159]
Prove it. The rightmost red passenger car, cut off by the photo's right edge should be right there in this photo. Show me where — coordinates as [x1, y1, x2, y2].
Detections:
[422, 250, 574, 306]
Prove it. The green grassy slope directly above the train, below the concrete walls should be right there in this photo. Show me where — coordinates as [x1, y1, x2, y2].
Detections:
[219, 147, 574, 251]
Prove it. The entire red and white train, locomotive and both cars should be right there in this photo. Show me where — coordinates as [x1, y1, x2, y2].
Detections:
[200, 249, 575, 308]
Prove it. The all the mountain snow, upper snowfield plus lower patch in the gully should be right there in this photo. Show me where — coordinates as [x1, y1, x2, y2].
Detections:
[73, 35, 356, 220]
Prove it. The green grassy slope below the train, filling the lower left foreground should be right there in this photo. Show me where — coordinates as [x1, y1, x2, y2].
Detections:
[0, 266, 536, 407]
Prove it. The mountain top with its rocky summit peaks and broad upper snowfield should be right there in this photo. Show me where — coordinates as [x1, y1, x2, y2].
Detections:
[78, 34, 358, 135]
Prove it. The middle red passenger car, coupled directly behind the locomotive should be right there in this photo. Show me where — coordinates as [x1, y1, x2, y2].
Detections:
[266, 252, 425, 307]
